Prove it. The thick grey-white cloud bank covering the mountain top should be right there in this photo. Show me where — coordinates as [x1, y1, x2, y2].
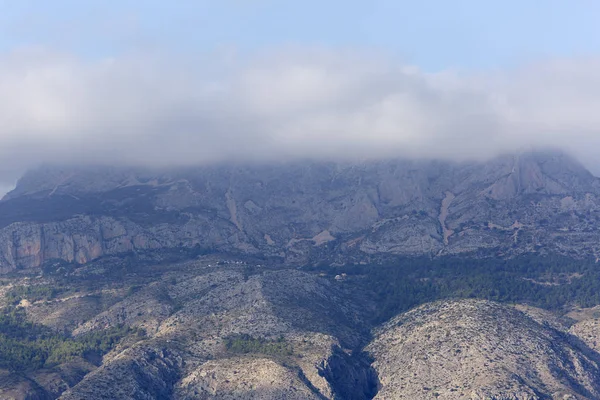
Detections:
[0, 49, 600, 186]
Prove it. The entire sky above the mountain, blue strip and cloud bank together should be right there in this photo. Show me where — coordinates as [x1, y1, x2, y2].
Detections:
[0, 0, 600, 190]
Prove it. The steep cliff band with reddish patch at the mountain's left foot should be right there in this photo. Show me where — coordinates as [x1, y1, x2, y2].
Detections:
[0, 215, 237, 272]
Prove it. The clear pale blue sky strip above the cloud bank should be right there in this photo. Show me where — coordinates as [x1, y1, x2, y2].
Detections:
[0, 0, 600, 71]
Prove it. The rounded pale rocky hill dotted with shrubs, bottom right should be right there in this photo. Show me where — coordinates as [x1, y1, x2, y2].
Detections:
[367, 300, 600, 400]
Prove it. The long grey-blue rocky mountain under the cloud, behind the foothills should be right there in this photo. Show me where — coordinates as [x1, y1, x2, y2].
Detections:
[0, 153, 600, 272]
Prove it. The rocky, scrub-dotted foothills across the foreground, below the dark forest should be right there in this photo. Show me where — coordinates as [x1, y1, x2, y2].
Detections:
[0, 256, 600, 400]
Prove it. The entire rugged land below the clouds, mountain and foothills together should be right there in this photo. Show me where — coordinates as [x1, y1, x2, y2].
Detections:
[0, 153, 600, 400]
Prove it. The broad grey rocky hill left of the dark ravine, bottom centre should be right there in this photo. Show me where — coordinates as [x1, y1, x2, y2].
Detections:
[27, 261, 377, 399]
